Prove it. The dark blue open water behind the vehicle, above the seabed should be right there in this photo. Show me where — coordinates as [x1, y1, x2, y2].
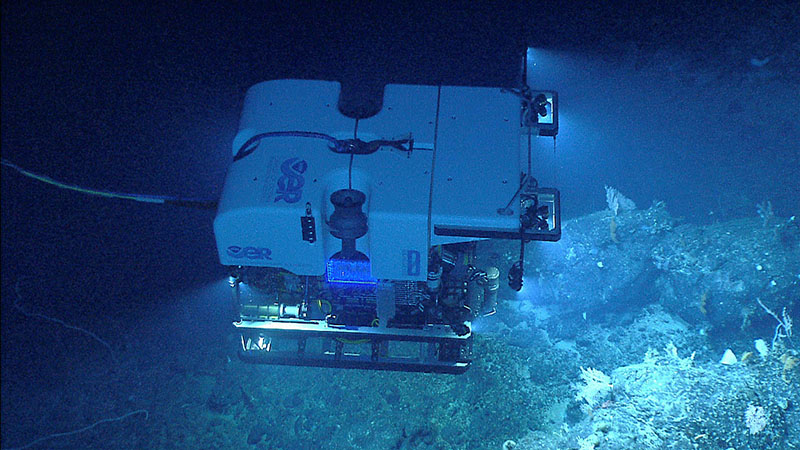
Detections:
[2, 1, 800, 340]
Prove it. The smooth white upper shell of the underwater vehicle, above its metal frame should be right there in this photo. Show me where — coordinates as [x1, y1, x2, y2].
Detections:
[214, 80, 521, 280]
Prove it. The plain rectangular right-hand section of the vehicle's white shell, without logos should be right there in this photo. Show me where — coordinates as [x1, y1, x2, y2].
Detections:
[433, 86, 519, 237]
